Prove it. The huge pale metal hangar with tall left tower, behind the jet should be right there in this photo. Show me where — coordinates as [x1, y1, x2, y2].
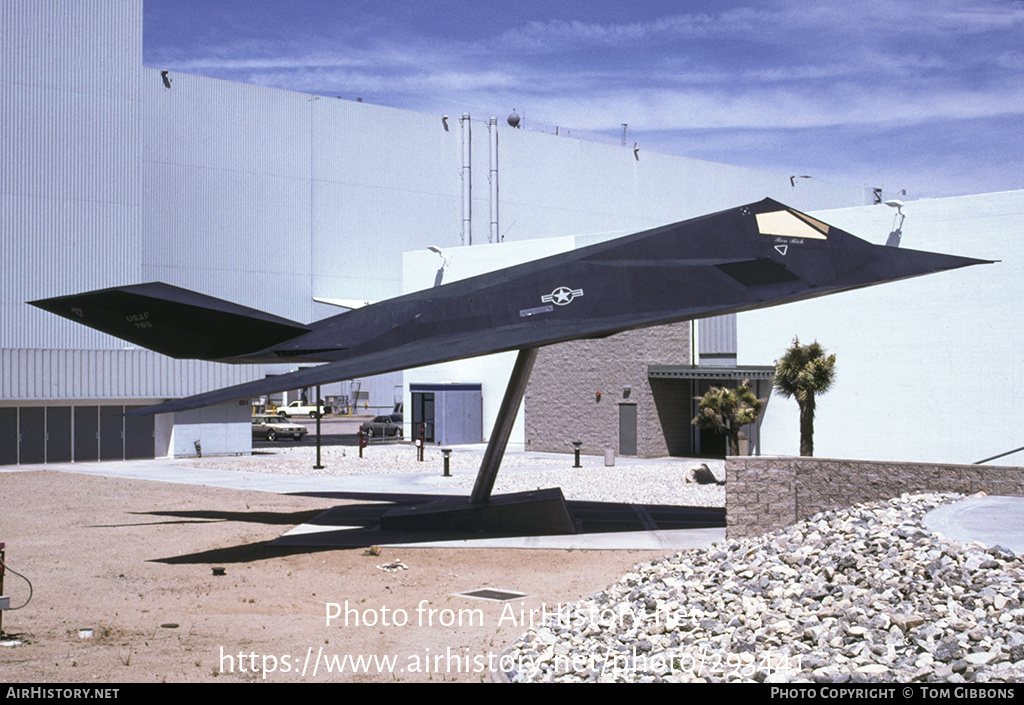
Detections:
[0, 0, 937, 463]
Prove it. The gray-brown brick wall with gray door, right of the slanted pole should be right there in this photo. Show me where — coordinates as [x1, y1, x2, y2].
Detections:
[524, 323, 690, 458]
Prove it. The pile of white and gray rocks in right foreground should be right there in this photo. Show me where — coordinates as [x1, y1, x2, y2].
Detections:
[503, 494, 1024, 682]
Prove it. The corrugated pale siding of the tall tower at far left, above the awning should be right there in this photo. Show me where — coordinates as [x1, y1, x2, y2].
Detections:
[0, 0, 142, 347]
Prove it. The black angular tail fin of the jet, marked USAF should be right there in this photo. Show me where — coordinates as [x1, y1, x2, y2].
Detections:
[29, 282, 310, 360]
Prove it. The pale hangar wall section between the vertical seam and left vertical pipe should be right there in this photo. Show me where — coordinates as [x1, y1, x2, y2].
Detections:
[311, 99, 460, 299]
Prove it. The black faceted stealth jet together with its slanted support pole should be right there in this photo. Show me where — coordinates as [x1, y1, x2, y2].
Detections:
[31, 199, 985, 532]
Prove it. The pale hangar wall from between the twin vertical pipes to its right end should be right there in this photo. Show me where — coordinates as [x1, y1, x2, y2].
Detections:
[499, 124, 864, 242]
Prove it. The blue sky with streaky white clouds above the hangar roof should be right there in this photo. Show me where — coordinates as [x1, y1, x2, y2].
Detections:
[143, 0, 1024, 198]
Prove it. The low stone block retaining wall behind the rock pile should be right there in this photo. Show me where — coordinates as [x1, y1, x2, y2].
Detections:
[725, 456, 1024, 538]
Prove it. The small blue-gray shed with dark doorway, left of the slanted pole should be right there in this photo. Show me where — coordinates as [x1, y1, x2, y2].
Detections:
[407, 382, 483, 446]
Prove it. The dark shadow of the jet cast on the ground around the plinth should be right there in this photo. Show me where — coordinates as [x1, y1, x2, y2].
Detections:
[146, 492, 725, 564]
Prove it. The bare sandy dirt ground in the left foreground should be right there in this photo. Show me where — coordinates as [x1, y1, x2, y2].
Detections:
[0, 470, 662, 683]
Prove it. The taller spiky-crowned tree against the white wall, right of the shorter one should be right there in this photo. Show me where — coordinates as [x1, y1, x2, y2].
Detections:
[773, 338, 836, 456]
